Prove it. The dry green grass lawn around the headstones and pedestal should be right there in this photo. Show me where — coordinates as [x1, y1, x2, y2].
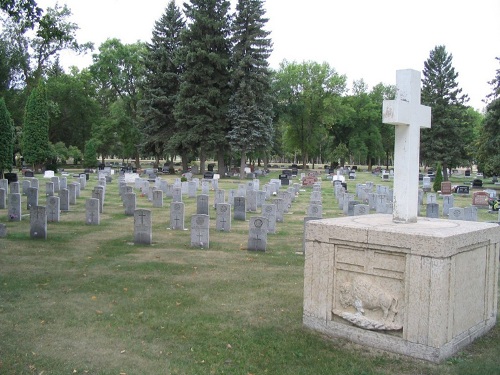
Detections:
[0, 172, 500, 375]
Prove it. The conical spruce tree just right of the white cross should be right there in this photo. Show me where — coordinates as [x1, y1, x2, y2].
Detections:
[420, 46, 472, 181]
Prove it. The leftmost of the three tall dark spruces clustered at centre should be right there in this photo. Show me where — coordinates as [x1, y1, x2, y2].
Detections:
[139, 0, 185, 167]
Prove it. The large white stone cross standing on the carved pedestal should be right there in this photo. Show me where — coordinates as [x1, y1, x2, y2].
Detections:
[382, 69, 431, 223]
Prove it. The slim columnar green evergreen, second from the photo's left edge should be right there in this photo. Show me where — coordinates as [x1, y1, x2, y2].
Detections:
[22, 80, 50, 170]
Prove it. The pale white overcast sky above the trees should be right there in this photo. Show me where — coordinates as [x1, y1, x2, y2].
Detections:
[38, 0, 500, 110]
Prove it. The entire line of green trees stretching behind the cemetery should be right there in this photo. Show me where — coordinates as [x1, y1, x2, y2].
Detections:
[0, 0, 500, 178]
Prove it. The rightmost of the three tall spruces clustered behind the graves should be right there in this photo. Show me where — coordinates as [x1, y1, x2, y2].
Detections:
[228, 0, 273, 178]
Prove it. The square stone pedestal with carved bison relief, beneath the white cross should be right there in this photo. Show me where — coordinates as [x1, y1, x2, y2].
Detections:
[303, 214, 500, 362]
